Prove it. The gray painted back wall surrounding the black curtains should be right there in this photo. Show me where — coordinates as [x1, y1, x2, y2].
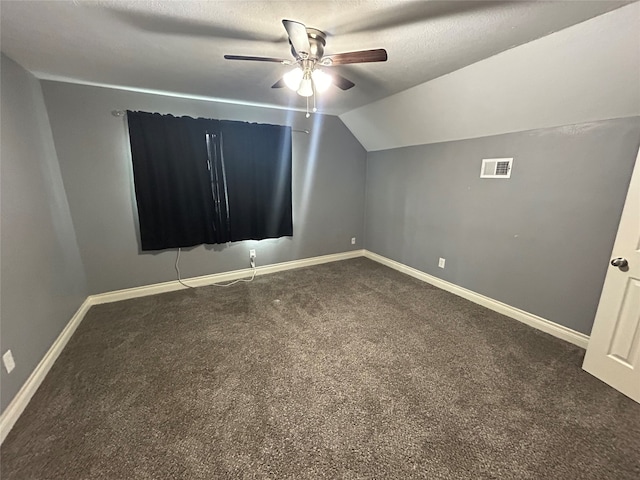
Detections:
[42, 82, 366, 294]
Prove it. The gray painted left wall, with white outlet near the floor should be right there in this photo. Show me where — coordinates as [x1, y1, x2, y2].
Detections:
[0, 55, 87, 411]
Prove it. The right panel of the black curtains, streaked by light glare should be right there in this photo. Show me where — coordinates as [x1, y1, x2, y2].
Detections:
[220, 120, 293, 241]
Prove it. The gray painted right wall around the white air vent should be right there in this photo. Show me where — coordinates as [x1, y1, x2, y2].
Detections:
[365, 117, 640, 334]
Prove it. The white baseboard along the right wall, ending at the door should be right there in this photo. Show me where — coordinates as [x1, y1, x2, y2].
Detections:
[364, 250, 589, 349]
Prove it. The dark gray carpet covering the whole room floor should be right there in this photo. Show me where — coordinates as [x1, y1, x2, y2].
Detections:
[1, 259, 640, 480]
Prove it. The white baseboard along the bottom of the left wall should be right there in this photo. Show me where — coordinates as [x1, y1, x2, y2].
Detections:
[0, 298, 91, 444]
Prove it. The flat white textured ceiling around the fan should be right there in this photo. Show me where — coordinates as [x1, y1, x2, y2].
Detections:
[0, 0, 631, 115]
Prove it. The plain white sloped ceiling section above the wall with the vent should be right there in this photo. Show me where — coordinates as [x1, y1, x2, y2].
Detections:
[340, 3, 640, 151]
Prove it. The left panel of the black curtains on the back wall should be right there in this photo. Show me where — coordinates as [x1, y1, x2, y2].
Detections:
[127, 111, 224, 250]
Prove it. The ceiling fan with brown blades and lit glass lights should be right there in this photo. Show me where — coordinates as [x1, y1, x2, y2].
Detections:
[224, 20, 387, 116]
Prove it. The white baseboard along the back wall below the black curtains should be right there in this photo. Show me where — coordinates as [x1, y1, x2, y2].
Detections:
[89, 250, 364, 305]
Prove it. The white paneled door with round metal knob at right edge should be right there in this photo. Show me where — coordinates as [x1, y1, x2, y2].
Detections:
[582, 146, 640, 403]
